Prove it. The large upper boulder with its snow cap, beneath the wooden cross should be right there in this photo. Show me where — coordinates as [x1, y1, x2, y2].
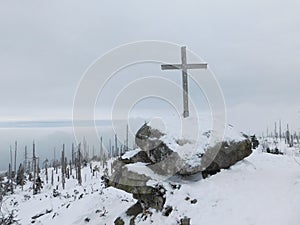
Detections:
[135, 118, 252, 175]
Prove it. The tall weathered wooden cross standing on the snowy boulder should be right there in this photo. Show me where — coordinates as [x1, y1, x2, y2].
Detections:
[161, 46, 207, 118]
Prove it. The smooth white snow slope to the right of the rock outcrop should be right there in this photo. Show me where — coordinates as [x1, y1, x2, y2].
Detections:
[149, 149, 300, 225]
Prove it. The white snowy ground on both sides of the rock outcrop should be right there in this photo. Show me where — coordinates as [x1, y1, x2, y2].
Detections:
[3, 150, 300, 225]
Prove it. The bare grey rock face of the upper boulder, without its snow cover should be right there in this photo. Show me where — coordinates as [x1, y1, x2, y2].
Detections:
[133, 124, 252, 177]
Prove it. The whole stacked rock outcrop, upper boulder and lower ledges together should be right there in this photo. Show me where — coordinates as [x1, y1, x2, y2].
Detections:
[104, 119, 252, 224]
